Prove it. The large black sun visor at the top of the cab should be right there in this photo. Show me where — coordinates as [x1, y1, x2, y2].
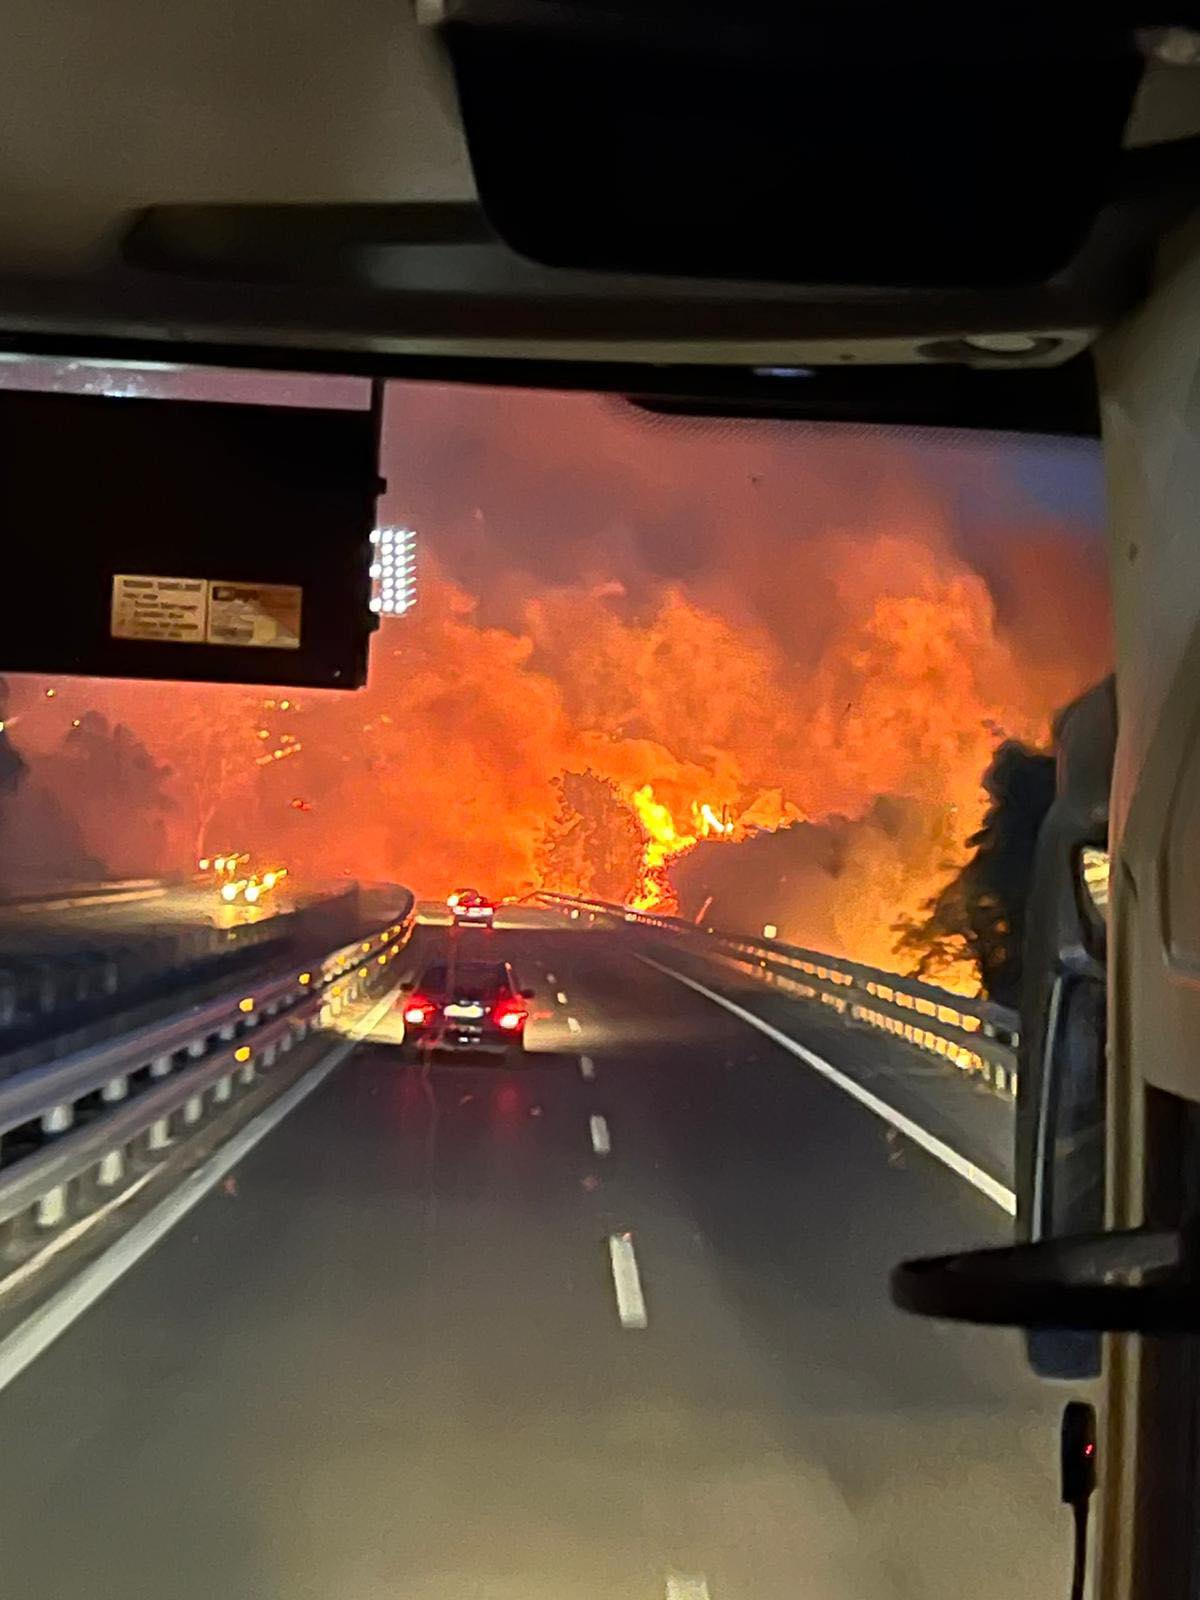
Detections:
[438, 0, 1142, 294]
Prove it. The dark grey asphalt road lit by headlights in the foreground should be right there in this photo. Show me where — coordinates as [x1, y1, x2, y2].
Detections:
[0, 912, 1069, 1600]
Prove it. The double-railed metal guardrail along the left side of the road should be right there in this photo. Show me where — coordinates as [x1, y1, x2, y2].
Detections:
[0, 891, 416, 1235]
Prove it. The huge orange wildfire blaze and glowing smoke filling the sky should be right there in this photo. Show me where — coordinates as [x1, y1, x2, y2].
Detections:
[5, 386, 1109, 981]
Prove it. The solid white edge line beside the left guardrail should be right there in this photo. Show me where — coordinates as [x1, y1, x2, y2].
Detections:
[0, 994, 394, 1390]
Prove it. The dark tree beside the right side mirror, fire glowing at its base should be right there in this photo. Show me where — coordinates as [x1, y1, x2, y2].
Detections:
[896, 739, 1054, 1006]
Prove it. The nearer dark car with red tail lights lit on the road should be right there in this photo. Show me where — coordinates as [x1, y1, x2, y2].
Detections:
[402, 962, 533, 1056]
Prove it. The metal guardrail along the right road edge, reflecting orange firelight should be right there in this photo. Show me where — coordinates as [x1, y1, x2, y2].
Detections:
[531, 891, 1021, 1098]
